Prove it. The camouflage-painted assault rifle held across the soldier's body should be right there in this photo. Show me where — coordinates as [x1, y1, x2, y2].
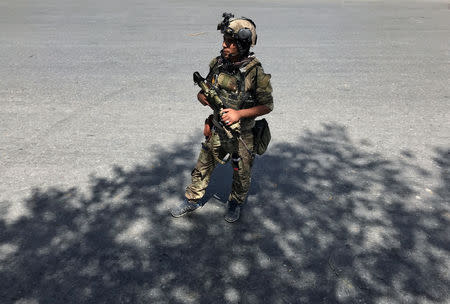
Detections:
[194, 72, 241, 139]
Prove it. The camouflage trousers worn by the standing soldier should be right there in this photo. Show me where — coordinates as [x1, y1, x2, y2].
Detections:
[185, 132, 253, 204]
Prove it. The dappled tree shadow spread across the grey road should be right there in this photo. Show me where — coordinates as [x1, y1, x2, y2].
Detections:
[0, 124, 450, 304]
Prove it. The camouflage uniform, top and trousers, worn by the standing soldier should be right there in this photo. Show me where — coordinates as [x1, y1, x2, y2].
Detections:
[185, 56, 273, 204]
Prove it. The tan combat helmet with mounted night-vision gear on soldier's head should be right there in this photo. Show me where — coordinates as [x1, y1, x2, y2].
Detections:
[217, 13, 257, 55]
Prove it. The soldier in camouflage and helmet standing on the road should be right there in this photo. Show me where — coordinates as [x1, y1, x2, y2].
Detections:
[171, 13, 273, 223]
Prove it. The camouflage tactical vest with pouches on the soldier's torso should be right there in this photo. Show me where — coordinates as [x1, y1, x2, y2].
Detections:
[208, 57, 261, 131]
